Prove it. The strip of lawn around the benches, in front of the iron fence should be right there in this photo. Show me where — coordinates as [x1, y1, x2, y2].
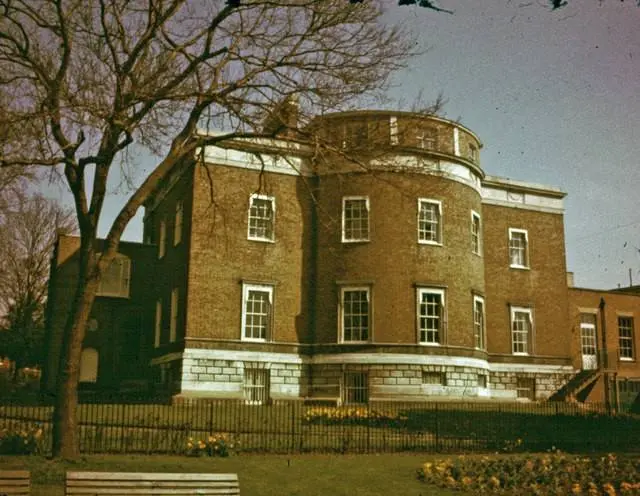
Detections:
[0, 454, 462, 496]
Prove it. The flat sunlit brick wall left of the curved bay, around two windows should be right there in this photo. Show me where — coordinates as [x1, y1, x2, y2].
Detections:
[187, 165, 313, 343]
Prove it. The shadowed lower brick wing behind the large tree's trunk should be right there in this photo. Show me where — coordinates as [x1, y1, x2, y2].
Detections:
[42, 235, 156, 392]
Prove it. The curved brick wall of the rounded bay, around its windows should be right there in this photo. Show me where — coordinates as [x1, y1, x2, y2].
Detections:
[315, 171, 484, 354]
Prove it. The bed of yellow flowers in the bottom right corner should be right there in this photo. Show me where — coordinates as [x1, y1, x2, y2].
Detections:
[418, 452, 640, 496]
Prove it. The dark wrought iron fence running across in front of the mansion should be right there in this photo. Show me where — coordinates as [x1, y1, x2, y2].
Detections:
[0, 398, 640, 454]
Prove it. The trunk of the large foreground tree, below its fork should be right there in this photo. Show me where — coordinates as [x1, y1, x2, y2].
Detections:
[52, 241, 98, 459]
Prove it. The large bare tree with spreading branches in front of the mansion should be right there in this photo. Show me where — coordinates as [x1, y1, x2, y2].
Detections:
[0, 0, 415, 457]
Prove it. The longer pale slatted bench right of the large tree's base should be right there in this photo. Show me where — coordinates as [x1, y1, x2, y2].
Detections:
[65, 472, 240, 496]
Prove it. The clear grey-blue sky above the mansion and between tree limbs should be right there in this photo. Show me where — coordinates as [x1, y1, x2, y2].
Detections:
[42, 0, 640, 289]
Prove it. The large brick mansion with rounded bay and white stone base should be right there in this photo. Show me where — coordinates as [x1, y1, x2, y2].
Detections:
[45, 111, 640, 403]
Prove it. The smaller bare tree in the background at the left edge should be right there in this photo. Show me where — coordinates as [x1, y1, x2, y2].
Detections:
[0, 192, 75, 378]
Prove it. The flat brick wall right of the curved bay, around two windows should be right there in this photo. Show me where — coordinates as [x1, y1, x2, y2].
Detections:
[482, 204, 571, 357]
